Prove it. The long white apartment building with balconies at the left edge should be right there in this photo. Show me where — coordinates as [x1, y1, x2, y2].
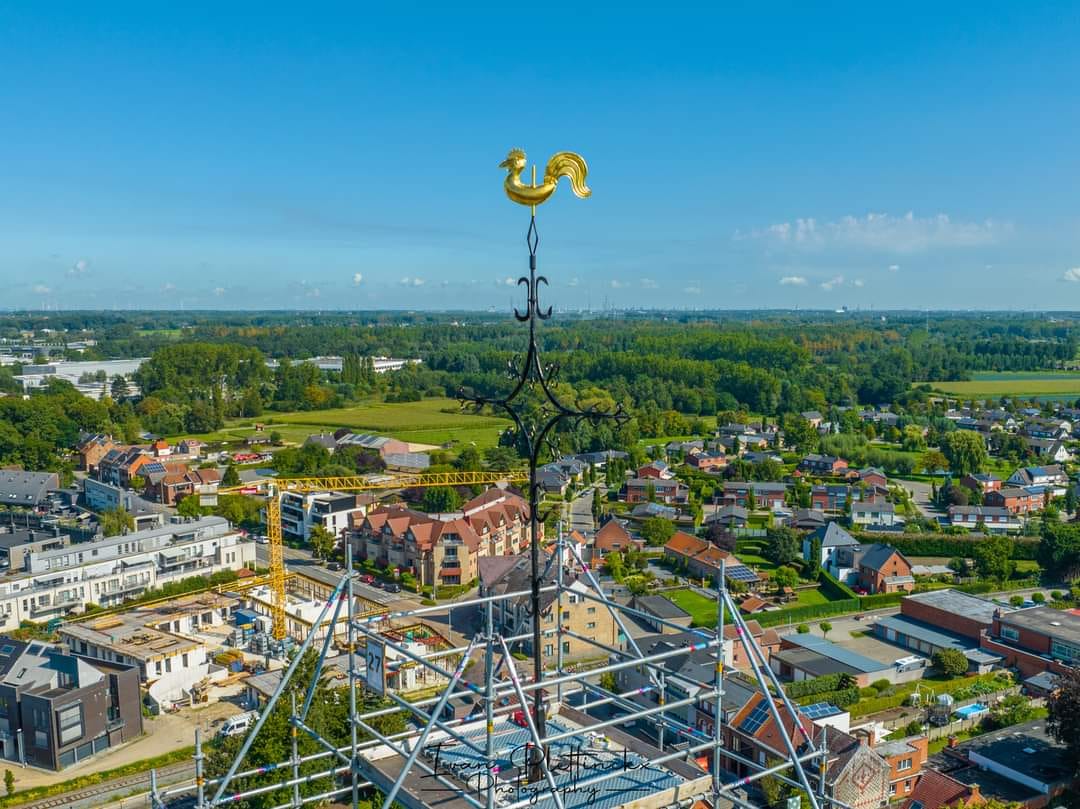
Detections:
[0, 516, 255, 632]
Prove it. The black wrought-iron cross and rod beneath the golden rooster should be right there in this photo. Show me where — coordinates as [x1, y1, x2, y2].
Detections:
[459, 210, 630, 782]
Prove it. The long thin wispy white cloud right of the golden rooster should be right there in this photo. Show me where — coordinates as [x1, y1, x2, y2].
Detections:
[734, 211, 1012, 252]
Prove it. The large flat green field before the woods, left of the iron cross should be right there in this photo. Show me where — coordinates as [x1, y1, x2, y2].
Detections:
[171, 399, 510, 449]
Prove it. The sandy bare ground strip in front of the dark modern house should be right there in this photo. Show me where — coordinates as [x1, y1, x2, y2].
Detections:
[5, 702, 240, 790]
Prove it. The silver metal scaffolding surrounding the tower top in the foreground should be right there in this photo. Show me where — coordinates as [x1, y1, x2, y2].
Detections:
[151, 537, 868, 809]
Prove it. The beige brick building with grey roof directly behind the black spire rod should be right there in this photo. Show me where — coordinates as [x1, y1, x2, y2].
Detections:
[480, 554, 622, 666]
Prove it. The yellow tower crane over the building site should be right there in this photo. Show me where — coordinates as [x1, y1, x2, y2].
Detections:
[217, 470, 528, 641]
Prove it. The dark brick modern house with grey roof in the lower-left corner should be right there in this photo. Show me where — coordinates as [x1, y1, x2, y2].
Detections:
[0, 637, 143, 770]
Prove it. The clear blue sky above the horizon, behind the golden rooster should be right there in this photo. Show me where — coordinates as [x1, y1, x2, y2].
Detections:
[0, 2, 1080, 309]
